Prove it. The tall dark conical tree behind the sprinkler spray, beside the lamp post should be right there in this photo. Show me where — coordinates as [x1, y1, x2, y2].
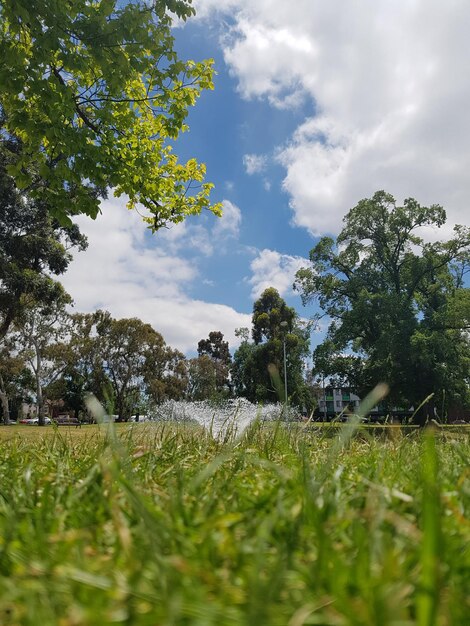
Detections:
[232, 287, 310, 406]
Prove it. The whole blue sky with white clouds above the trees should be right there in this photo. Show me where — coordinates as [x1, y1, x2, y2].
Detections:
[62, 0, 470, 356]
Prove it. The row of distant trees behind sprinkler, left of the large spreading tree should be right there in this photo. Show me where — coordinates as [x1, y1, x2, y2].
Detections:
[0, 289, 316, 424]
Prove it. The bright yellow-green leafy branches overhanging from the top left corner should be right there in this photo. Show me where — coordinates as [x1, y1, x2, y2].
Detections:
[0, 0, 220, 230]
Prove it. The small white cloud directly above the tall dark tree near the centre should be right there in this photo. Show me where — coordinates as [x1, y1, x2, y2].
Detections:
[248, 249, 308, 299]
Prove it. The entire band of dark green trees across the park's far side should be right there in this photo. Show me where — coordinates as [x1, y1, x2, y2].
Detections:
[0, 140, 470, 422]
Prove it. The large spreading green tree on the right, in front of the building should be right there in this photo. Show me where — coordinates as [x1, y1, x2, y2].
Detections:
[296, 191, 470, 420]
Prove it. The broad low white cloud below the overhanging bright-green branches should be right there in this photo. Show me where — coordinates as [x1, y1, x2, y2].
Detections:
[62, 200, 250, 352]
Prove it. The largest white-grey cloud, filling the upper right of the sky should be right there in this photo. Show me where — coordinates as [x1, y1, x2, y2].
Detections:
[196, 0, 470, 235]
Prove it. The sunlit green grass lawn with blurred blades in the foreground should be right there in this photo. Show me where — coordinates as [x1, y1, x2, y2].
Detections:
[0, 424, 470, 626]
